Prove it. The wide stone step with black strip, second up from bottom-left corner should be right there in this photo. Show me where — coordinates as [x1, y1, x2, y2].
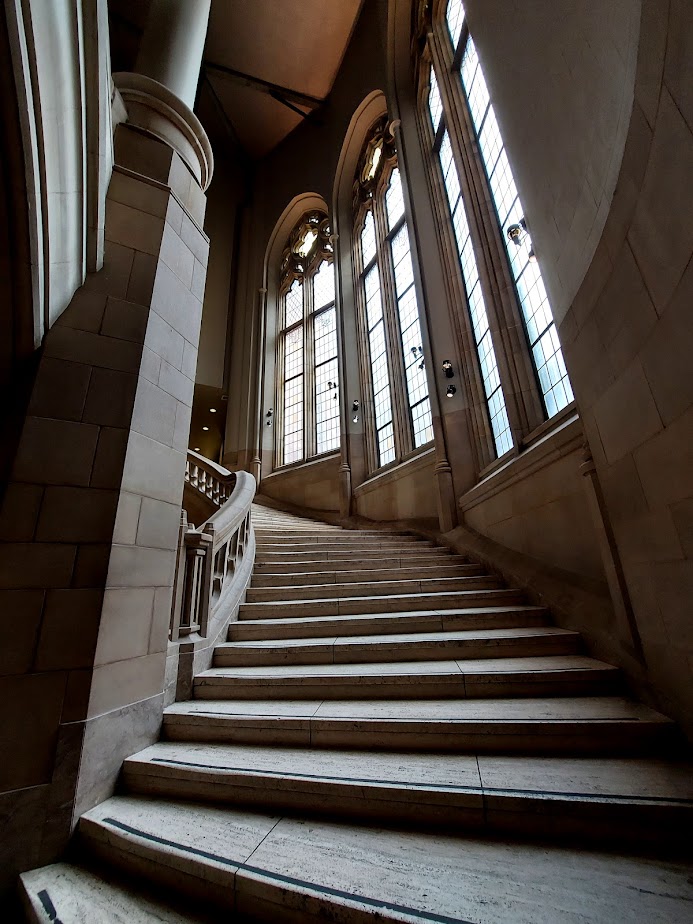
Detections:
[79, 796, 693, 924]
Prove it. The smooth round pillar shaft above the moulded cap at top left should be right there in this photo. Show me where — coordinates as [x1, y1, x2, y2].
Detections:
[135, 0, 211, 109]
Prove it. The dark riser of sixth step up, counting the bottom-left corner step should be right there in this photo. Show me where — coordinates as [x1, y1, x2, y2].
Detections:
[214, 636, 582, 667]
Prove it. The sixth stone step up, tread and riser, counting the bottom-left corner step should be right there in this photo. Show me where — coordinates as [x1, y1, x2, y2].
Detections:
[213, 627, 582, 667]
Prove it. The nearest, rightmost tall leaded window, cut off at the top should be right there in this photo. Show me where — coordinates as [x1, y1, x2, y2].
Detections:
[417, 0, 573, 456]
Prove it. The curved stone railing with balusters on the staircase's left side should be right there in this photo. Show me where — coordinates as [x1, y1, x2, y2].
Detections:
[169, 451, 255, 699]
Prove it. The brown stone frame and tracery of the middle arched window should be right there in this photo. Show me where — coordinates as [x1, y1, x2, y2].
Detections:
[352, 117, 434, 477]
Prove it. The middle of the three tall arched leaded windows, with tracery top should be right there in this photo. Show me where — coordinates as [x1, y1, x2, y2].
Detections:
[354, 119, 433, 470]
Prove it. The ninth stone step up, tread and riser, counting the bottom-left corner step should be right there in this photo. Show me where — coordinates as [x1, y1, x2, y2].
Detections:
[246, 574, 502, 603]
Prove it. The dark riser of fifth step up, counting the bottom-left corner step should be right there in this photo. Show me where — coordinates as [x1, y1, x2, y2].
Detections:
[194, 670, 618, 700]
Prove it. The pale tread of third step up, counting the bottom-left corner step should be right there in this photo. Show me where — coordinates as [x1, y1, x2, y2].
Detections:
[125, 742, 693, 804]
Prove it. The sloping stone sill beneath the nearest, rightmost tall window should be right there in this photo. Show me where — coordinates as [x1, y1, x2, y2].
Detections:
[458, 412, 584, 511]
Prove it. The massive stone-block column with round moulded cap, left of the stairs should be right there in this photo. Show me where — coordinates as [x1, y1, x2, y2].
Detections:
[0, 0, 212, 889]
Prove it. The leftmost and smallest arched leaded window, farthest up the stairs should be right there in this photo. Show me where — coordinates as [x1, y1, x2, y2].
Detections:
[276, 212, 339, 465]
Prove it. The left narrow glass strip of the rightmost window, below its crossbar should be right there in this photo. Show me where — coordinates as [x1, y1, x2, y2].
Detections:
[438, 130, 513, 456]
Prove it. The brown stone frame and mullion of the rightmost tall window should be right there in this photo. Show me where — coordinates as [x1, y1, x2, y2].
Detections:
[412, 0, 574, 476]
